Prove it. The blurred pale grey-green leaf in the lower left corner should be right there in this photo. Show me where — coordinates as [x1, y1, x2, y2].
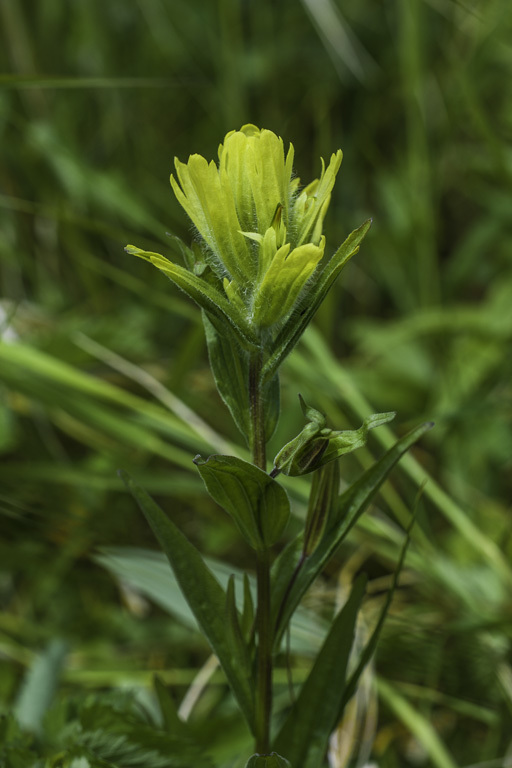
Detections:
[14, 639, 67, 733]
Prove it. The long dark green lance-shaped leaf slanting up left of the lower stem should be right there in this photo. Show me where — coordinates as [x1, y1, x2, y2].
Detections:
[119, 471, 254, 728]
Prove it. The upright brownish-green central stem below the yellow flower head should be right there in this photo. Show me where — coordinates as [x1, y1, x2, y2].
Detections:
[249, 352, 273, 754]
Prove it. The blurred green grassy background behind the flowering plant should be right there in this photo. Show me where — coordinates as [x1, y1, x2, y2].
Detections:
[0, 0, 512, 768]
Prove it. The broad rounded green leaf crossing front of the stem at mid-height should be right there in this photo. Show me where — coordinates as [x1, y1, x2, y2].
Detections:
[194, 455, 290, 549]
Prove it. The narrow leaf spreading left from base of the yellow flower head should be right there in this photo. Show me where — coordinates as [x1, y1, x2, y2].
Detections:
[125, 245, 258, 347]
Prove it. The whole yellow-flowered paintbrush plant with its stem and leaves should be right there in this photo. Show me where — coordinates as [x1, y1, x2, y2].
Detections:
[124, 125, 430, 768]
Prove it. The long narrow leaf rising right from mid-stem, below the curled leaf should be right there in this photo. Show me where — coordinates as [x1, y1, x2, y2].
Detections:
[272, 422, 433, 648]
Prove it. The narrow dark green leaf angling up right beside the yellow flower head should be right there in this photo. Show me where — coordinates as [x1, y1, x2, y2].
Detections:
[262, 219, 371, 381]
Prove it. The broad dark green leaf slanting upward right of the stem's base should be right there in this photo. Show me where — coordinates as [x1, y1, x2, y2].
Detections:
[274, 575, 366, 768]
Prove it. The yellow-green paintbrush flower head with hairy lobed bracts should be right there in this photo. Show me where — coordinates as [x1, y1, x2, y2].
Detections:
[128, 124, 366, 342]
